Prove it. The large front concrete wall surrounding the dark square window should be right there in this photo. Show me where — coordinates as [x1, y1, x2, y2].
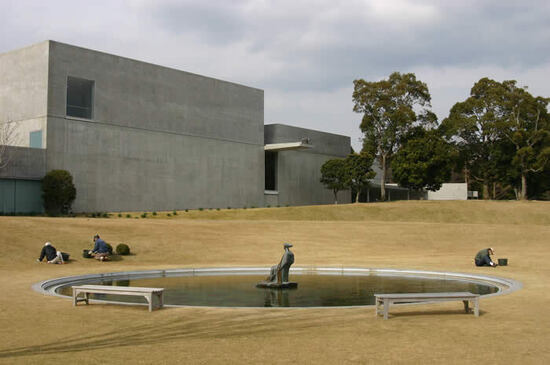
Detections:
[47, 42, 264, 211]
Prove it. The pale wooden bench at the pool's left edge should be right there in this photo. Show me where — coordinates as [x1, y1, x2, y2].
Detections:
[73, 285, 164, 312]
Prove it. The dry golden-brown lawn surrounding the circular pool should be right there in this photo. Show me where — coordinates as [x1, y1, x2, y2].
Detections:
[0, 202, 550, 364]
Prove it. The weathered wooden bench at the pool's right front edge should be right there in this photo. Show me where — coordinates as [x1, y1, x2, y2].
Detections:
[374, 292, 479, 319]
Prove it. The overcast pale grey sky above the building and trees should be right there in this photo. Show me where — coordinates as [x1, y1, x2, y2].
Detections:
[0, 0, 550, 149]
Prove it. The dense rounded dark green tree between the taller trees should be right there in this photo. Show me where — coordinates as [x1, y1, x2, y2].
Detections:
[391, 128, 453, 191]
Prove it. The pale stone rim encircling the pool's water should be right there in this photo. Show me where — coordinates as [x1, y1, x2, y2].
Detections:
[32, 267, 523, 309]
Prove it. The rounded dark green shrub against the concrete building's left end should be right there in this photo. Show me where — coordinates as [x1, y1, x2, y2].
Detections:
[42, 170, 76, 215]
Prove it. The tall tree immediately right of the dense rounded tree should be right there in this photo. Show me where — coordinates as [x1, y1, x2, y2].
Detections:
[441, 78, 505, 199]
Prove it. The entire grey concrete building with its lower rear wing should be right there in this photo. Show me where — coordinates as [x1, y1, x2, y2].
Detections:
[0, 41, 350, 212]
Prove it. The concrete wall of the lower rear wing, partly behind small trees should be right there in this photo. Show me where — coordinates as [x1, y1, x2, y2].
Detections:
[264, 124, 351, 206]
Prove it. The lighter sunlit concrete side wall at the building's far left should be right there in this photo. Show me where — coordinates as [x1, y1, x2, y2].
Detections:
[0, 42, 49, 148]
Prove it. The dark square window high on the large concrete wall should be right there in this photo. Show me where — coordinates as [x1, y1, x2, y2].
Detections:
[67, 76, 94, 119]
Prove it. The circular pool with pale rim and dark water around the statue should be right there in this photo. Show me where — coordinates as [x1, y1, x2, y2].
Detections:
[33, 267, 521, 308]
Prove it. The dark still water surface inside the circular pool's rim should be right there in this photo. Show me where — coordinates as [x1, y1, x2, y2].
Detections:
[58, 275, 497, 307]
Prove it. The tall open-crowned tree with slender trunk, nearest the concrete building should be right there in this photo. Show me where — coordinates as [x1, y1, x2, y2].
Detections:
[353, 72, 437, 200]
